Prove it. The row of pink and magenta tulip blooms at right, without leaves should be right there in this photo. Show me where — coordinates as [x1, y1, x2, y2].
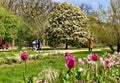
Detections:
[65, 52, 120, 69]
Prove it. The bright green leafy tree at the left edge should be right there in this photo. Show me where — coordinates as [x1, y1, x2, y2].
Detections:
[0, 7, 20, 46]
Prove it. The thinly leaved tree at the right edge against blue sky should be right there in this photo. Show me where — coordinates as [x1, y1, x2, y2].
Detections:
[94, 0, 120, 52]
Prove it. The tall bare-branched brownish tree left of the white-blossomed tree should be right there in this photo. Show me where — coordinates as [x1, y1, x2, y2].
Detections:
[2, 0, 57, 46]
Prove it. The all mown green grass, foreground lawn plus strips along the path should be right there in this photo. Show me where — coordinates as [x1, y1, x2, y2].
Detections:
[0, 47, 112, 83]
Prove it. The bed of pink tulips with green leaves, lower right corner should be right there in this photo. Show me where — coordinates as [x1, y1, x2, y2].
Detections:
[63, 52, 120, 83]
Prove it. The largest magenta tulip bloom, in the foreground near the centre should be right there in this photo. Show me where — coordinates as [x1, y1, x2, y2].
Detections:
[66, 55, 76, 68]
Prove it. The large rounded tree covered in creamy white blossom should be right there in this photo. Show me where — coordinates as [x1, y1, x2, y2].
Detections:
[46, 3, 90, 49]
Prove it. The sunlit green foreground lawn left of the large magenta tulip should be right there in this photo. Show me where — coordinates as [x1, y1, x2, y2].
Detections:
[0, 59, 64, 83]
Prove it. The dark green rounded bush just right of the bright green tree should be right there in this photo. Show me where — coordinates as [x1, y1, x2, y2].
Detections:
[16, 22, 34, 50]
